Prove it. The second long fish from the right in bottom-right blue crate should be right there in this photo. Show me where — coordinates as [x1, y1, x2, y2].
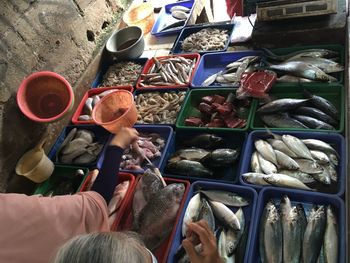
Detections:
[302, 206, 326, 263]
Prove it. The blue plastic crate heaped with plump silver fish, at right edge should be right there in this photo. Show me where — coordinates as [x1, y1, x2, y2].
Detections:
[239, 131, 347, 196]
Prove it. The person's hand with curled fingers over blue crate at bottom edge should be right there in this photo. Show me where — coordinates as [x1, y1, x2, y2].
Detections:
[182, 220, 222, 263]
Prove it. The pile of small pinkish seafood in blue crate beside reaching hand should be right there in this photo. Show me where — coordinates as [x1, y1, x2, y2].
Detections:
[120, 133, 165, 171]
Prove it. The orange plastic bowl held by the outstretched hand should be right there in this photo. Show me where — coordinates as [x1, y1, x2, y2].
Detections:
[92, 90, 137, 133]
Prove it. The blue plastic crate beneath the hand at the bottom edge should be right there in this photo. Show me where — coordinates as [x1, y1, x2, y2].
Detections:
[167, 181, 258, 263]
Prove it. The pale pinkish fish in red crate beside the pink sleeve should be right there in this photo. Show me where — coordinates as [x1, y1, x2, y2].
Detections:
[108, 180, 130, 226]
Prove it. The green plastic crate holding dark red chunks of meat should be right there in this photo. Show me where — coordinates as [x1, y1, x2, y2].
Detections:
[176, 89, 255, 132]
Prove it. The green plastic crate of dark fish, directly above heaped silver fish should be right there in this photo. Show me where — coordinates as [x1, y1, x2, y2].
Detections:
[251, 83, 345, 133]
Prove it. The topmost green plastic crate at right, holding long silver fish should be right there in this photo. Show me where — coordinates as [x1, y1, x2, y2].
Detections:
[271, 45, 345, 85]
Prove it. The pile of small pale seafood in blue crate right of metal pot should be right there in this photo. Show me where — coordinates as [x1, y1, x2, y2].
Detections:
[181, 28, 228, 52]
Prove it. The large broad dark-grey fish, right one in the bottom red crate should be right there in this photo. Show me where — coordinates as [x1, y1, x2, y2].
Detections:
[134, 183, 185, 251]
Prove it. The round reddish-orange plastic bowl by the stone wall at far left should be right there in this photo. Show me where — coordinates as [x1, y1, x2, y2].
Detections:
[17, 71, 74, 122]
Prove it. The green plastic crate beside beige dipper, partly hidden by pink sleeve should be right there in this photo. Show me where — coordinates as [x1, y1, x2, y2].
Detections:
[33, 165, 89, 196]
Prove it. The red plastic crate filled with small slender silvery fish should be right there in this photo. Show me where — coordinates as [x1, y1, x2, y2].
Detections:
[136, 53, 200, 90]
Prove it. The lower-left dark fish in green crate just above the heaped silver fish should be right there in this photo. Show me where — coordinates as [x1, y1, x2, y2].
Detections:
[260, 113, 307, 129]
